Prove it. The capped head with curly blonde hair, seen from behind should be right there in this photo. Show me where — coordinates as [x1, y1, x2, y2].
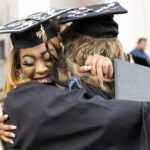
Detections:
[58, 3, 127, 97]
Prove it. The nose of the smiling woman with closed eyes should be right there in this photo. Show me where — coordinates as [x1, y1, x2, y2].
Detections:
[36, 62, 49, 74]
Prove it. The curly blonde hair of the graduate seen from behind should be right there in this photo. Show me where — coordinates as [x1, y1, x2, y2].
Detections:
[58, 26, 126, 95]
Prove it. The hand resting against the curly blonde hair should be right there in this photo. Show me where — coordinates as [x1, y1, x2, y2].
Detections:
[80, 54, 113, 80]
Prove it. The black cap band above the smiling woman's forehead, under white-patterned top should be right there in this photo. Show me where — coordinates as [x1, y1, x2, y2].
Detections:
[10, 20, 57, 48]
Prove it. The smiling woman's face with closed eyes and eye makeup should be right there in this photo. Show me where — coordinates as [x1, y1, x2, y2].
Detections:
[19, 43, 55, 83]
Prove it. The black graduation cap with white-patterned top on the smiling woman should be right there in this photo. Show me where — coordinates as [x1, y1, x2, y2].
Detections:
[0, 9, 70, 48]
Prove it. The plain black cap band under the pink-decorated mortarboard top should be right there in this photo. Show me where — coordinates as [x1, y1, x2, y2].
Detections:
[72, 15, 119, 38]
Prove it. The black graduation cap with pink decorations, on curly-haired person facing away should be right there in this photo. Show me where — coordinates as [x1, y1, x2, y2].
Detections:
[59, 2, 127, 38]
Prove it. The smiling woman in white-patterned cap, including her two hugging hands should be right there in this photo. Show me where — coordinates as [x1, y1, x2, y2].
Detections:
[0, 9, 113, 144]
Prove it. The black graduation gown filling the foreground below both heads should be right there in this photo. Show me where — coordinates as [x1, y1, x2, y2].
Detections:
[4, 82, 150, 150]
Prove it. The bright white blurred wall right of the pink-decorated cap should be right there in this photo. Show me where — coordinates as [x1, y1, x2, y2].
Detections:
[115, 0, 150, 55]
